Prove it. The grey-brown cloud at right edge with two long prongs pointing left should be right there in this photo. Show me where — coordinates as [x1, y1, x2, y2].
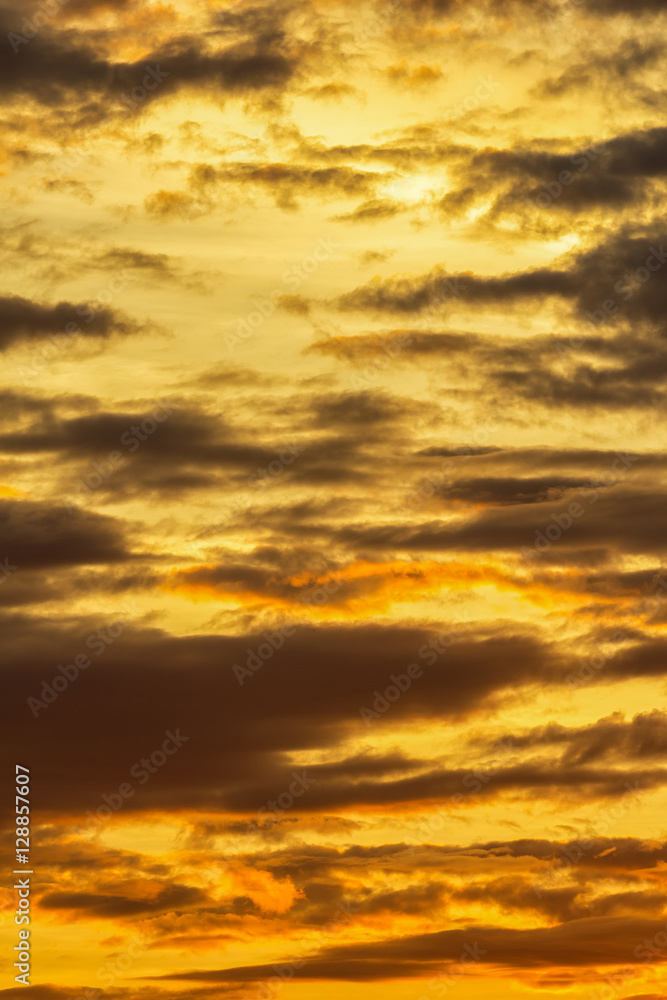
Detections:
[322, 233, 667, 411]
